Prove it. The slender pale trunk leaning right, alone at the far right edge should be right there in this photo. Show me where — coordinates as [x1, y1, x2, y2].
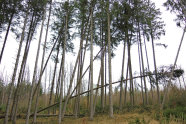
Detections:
[161, 26, 186, 110]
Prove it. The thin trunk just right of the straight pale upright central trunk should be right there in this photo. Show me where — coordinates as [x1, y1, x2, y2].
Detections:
[119, 40, 126, 112]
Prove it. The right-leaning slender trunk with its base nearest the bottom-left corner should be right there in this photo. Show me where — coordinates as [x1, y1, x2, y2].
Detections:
[4, 5, 30, 124]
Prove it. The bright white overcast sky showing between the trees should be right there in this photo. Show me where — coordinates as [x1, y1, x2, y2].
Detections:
[0, 0, 186, 90]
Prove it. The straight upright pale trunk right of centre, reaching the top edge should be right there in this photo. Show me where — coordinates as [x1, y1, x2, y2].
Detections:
[107, 0, 114, 118]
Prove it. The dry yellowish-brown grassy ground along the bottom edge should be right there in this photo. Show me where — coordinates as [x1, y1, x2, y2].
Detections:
[0, 112, 184, 124]
